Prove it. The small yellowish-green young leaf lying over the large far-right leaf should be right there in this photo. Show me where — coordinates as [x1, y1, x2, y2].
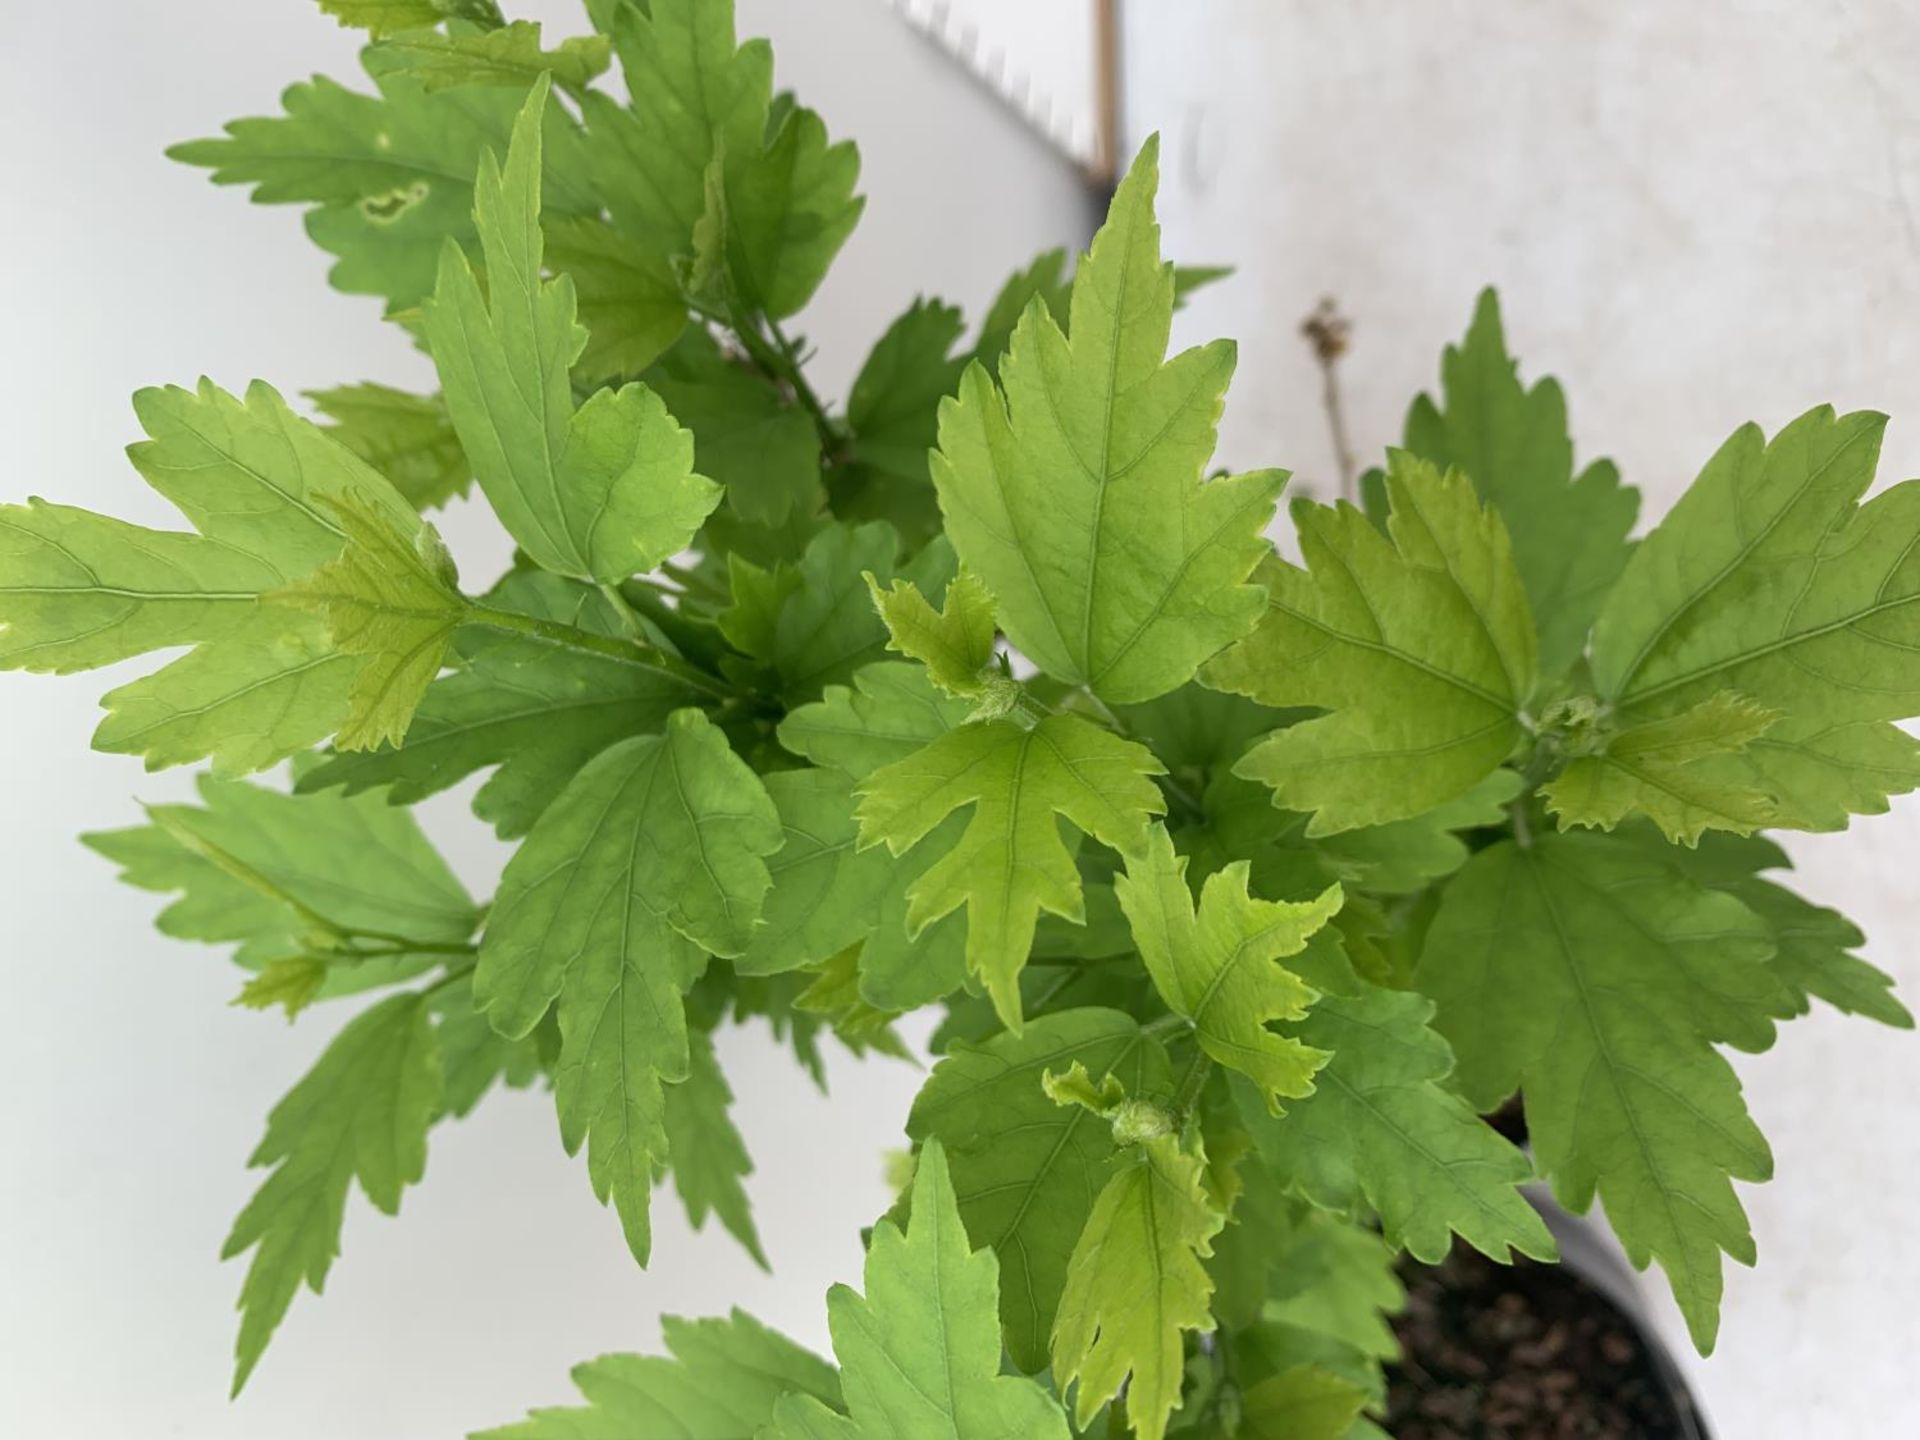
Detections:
[1540, 689, 1780, 845]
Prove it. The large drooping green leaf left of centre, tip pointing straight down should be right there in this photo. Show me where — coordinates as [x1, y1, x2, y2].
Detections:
[474, 710, 783, 1263]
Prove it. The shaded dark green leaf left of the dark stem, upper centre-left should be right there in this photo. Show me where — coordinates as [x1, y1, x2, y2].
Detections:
[647, 328, 820, 526]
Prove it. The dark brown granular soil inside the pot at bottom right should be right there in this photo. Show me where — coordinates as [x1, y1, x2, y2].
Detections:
[1386, 1246, 1697, 1440]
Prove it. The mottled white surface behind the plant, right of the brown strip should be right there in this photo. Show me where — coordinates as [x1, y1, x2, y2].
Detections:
[1125, 0, 1920, 1440]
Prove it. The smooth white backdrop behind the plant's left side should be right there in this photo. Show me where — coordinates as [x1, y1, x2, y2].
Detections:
[0, 0, 1089, 1440]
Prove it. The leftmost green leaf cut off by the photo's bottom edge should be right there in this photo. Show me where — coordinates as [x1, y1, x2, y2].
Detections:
[470, 1309, 841, 1440]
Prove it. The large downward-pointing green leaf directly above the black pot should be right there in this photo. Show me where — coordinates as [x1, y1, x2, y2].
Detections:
[1417, 835, 1793, 1354]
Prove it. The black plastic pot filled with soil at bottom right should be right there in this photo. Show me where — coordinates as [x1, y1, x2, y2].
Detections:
[1388, 1194, 1711, 1440]
